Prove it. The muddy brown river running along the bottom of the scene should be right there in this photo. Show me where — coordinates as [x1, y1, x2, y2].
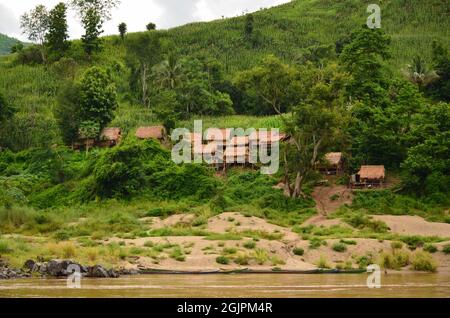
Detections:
[0, 273, 450, 298]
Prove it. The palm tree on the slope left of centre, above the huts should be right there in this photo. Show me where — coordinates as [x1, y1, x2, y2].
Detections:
[153, 54, 183, 90]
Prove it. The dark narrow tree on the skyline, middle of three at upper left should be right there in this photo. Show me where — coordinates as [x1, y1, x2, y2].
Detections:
[45, 2, 70, 57]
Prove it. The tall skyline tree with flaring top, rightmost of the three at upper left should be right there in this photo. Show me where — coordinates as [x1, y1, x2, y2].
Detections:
[71, 0, 120, 56]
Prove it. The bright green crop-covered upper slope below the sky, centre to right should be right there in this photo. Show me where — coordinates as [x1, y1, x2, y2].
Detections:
[162, 0, 450, 72]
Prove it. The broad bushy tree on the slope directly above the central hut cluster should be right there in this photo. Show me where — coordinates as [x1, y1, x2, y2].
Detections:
[234, 55, 299, 115]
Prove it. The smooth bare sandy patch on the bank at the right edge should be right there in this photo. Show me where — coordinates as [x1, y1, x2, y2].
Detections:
[373, 215, 450, 238]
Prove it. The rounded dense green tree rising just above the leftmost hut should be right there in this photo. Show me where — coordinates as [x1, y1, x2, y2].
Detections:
[79, 67, 117, 130]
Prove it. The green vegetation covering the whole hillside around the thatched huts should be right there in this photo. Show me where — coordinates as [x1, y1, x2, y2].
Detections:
[0, 0, 450, 270]
